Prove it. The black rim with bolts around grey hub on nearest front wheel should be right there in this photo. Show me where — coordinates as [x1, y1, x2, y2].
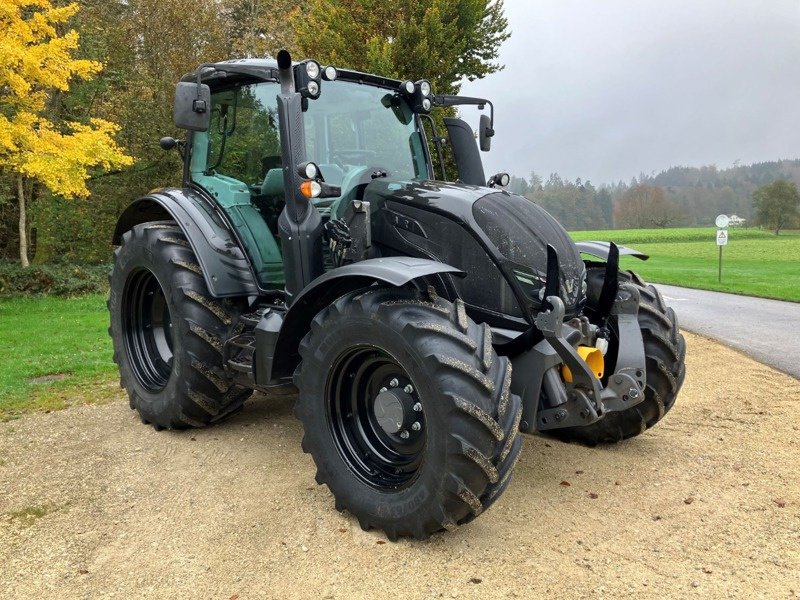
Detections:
[326, 346, 427, 490]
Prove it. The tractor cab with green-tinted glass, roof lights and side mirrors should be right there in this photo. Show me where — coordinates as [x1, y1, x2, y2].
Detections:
[176, 59, 491, 300]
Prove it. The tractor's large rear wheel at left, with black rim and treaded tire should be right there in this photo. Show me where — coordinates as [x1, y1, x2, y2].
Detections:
[108, 221, 251, 429]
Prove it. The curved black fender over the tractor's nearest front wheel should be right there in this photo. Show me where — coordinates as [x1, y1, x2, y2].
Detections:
[256, 256, 465, 385]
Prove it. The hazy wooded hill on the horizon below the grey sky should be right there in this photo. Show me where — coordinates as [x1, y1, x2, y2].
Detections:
[509, 159, 800, 230]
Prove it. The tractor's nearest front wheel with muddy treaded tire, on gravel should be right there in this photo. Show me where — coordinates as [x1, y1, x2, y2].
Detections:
[295, 288, 522, 540]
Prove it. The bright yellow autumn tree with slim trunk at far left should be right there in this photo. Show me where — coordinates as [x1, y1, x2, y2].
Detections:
[0, 0, 133, 267]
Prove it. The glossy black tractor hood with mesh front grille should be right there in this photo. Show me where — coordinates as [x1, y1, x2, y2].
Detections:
[363, 179, 586, 319]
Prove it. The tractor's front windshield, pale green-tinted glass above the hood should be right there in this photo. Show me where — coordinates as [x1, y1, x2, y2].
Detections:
[305, 80, 429, 186]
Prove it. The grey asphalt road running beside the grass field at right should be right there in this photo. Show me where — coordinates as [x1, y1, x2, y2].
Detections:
[656, 283, 800, 379]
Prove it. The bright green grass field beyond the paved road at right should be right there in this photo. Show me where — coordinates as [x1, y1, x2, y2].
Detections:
[571, 228, 800, 302]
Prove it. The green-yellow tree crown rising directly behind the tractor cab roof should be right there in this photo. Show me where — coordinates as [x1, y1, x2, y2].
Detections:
[293, 0, 511, 94]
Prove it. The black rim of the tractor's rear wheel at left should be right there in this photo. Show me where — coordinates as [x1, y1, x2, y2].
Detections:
[122, 269, 173, 392]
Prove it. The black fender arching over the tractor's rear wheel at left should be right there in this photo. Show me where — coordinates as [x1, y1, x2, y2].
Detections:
[112, 188, 259, 298]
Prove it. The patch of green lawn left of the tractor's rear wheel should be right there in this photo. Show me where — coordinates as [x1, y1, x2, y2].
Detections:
[0, 295, 116, 421]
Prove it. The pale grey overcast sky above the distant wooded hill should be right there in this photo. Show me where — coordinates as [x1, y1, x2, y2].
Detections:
[461, 0, 800, 183]
